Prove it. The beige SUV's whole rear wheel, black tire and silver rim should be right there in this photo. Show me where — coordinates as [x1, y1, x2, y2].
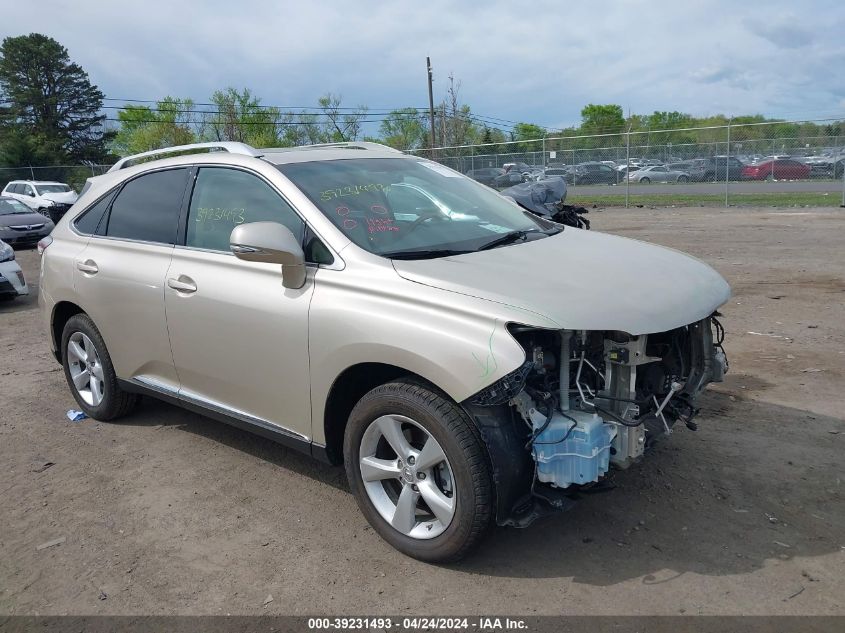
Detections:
[61, 314, 138, 421]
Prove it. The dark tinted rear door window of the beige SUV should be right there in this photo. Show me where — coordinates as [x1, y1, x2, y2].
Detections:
[106, 168, 188, 244]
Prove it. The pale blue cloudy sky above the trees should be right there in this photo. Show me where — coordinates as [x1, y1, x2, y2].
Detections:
[0, 0, 845, 128]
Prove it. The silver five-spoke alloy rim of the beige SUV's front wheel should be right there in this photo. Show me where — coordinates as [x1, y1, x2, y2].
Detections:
[359, 415, 457, 539]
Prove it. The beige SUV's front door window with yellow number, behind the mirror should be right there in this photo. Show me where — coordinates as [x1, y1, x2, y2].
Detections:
[185, 167, 304, 252]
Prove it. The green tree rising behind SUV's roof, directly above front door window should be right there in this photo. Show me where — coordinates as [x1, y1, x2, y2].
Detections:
[204, 88, 281, 147]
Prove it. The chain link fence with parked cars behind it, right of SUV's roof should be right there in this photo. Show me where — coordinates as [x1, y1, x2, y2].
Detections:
[412, 120, 845, 206]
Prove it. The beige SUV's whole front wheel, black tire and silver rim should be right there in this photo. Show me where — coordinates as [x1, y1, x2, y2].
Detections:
[343, 381, 494, 563]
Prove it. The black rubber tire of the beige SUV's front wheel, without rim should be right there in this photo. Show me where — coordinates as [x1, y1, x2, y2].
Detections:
[343, 381, 494, 563]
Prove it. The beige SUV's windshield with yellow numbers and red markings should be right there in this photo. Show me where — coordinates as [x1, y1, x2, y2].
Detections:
[277, 158, 554, 257]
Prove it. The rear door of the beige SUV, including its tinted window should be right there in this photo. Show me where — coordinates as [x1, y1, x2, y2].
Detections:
[74, 167, 189, 394]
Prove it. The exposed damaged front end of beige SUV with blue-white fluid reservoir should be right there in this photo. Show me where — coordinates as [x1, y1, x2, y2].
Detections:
[464, 313, 728, 527]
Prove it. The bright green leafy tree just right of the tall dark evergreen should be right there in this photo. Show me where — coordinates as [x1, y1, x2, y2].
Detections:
[112, 97, 197, 156]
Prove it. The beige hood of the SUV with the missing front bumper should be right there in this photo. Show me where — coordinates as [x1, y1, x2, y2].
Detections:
[393, 227, 730, 334]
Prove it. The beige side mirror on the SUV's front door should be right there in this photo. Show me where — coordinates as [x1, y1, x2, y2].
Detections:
[229, 222, 305, 289]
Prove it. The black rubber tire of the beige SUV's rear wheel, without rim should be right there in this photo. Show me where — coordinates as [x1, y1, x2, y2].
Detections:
[61, 314, 138, 421]
